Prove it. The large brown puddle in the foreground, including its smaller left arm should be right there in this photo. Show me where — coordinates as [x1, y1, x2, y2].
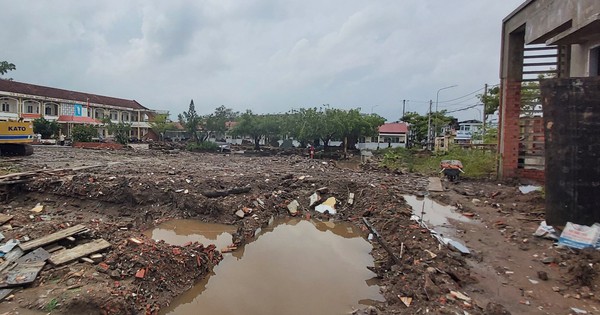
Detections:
[150, 218, 384, 315]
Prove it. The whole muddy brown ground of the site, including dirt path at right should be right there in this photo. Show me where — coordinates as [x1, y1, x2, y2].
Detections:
[0, 147, 600, 314]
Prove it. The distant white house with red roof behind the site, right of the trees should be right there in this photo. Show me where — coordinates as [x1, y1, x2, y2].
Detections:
[356, 122, 408, 150]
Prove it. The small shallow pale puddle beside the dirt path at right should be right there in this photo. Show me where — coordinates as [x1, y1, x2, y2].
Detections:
[403, 195, 471, 227]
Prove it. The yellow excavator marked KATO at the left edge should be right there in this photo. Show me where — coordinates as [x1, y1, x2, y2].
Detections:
[0, 120, 34, 156]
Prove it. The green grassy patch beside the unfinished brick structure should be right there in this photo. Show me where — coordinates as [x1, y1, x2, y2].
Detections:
[381, 148, 496, 178]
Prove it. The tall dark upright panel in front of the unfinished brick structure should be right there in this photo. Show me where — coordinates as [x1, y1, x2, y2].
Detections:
[541, 77, 600, 226]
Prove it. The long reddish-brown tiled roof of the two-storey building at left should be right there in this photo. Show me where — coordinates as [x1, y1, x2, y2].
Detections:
[0, 80, 148, 109]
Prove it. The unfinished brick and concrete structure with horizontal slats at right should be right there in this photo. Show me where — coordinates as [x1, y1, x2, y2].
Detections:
[498, 0, 600, 182]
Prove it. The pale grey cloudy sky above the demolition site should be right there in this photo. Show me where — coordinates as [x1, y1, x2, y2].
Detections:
[0, 0, 524, 121]
